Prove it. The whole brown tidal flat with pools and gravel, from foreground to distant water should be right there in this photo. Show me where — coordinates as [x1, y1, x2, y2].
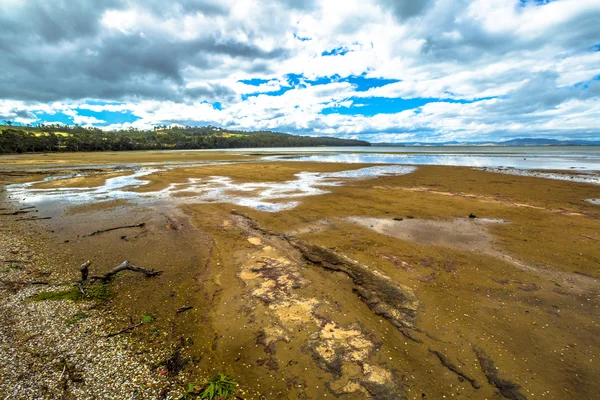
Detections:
[0, 150, 600, 399]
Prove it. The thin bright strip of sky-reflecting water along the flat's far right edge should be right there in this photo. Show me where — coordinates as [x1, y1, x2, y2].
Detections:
[274, 153, 600, 170]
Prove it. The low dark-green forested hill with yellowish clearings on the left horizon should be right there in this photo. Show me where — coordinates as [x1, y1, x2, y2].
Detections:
[0, 125, 370, 153]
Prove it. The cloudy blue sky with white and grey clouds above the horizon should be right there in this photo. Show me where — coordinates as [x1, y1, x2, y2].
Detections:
[0, 0, 600, 142]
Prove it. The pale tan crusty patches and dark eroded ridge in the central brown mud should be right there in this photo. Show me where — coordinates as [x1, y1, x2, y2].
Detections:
[233, 212, 418, 399]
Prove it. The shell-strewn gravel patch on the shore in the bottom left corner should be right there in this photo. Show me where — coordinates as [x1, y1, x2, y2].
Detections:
[0, 220, 183, 399]
